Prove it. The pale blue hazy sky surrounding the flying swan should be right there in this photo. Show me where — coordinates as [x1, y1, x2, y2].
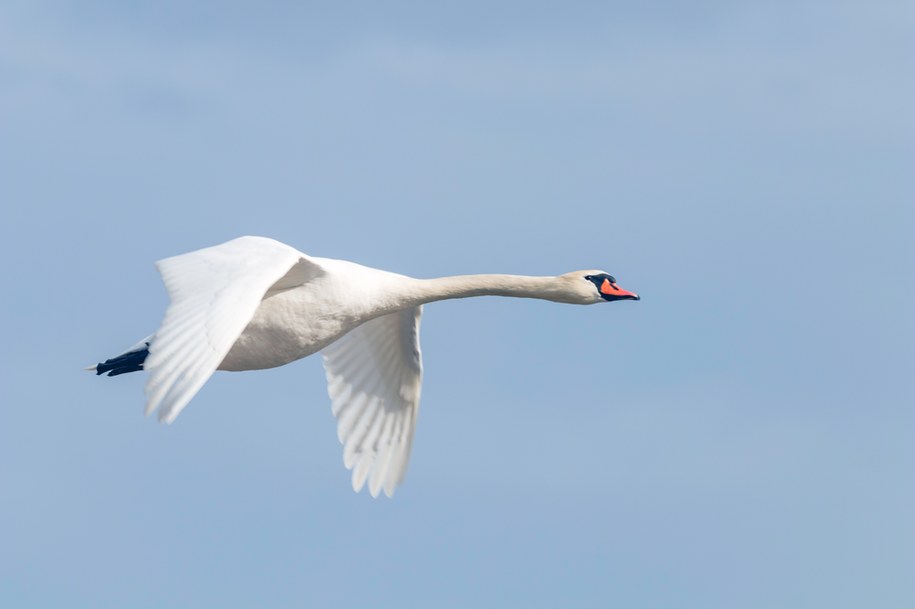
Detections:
[0, 1, 915, 609]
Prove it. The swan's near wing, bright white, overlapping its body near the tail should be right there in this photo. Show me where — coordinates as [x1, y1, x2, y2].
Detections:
[143, 237, 323, 423]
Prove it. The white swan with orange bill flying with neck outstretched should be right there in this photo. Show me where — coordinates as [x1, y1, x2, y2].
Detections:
[88, 236, 639, 497]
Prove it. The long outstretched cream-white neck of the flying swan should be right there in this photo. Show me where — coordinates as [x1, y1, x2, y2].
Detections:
[410, 275, 572, 304]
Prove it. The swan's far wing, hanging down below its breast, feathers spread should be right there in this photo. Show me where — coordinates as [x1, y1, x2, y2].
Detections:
[321, 307, 423, 497]
